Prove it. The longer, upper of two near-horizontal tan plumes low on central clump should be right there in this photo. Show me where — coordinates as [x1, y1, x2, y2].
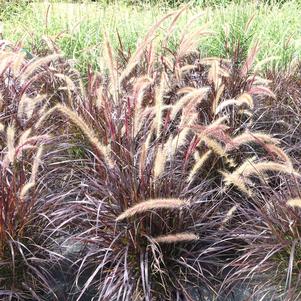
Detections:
[116, 199, 189, 222]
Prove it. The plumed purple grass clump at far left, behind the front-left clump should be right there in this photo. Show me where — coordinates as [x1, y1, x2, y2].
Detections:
[0, 46, 81, 130]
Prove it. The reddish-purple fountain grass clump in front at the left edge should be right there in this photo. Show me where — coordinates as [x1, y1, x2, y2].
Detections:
[0, 130, 55, 300]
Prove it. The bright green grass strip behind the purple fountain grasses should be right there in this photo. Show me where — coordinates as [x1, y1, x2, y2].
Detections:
[1, 0, 301, 72]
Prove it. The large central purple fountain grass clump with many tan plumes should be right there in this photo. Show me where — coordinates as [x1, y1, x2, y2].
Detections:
[38, 9, 299, 301]
